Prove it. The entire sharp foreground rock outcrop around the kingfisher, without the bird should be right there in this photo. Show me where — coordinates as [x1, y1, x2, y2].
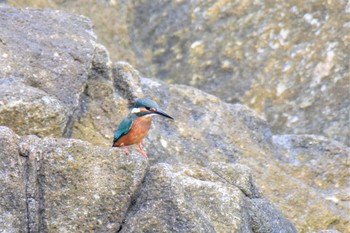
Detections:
[0, 6, 350, 232]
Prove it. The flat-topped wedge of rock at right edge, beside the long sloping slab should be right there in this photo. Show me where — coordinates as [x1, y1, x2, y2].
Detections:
[273, 135, 350, 206]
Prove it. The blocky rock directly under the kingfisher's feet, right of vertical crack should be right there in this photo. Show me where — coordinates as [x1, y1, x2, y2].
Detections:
[20, 136, 147, 232]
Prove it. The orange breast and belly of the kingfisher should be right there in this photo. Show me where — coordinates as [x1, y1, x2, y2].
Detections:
[114, 116, 152, 146]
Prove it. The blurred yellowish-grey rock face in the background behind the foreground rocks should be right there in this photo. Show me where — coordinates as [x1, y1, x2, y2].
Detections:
[6, 0, 350, 145]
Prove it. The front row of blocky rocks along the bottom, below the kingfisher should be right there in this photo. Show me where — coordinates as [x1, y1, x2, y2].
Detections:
[0, 127, 296, 232]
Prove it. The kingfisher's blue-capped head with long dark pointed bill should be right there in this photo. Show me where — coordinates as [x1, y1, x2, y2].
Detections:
[131, 98, 174, 119]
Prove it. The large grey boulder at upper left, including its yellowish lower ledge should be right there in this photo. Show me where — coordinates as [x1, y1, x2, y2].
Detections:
[0, 5, 96, 136]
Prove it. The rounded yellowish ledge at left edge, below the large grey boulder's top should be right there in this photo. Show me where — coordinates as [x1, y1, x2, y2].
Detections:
[0, 78, 68, 137]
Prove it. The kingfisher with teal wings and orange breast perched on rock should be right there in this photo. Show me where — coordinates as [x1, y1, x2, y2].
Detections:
[112, 98, 174, 158]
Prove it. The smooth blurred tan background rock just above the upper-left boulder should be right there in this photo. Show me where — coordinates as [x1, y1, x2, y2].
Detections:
[5, 0, 136, 64]
